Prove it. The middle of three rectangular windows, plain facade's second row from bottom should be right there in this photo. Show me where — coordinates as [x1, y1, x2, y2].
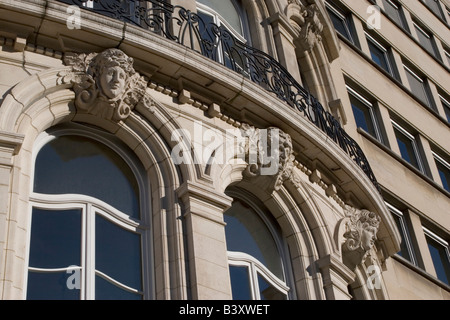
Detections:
[391, 120, 424, 172]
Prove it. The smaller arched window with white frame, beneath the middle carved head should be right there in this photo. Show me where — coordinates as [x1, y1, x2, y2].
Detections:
[224, 189, 290, 300]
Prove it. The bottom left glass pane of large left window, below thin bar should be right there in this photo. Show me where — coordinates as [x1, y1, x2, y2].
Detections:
[27, 271, 80, 300]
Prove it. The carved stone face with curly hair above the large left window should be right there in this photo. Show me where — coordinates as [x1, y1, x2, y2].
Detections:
[63, 49, 153, 121]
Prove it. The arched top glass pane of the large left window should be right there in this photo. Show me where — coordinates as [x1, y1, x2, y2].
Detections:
[34, 136, 139, 218]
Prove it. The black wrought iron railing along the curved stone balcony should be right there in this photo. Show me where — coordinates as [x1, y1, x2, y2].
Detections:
[58, 0, 378, 188]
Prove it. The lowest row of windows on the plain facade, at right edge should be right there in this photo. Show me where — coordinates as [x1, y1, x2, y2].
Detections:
[386, 202, 450, 285]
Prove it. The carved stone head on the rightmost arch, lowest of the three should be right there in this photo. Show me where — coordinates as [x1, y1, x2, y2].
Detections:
[342, 205, 381, 270]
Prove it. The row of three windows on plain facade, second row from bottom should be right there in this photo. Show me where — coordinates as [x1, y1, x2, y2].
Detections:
[347, 85, 450, 192]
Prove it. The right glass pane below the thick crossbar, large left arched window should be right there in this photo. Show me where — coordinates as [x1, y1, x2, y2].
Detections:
[95, 215, 142, 290]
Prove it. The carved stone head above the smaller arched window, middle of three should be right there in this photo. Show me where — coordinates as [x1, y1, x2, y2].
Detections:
[242, 124, 295, 190]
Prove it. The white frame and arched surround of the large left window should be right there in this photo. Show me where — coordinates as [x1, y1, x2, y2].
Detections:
[24, 124, 155, 300]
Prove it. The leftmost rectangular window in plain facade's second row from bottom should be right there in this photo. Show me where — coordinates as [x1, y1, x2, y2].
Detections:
[347, 86, 381, 141]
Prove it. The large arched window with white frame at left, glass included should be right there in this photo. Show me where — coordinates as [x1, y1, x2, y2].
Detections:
[27, 125, 150, 300]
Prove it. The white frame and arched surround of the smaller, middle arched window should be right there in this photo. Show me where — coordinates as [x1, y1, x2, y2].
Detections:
[227, 189, 295, 300]
